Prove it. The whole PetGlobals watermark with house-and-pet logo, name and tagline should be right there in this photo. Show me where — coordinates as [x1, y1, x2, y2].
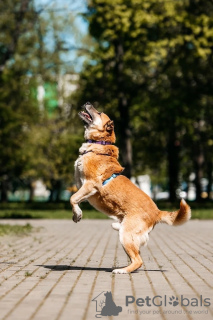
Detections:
[92, 291, 211, 318]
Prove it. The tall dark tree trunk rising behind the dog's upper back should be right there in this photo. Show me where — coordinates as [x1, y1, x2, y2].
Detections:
[114, 41, 132, 178]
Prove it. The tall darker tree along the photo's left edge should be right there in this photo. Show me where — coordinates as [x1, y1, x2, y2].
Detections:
[0, 0, 38, 201]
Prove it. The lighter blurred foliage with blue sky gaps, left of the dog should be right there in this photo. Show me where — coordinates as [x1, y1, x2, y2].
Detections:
[0, 0, 79, 200]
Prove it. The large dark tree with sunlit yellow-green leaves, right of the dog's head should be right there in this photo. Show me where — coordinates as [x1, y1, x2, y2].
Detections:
[74, 0, 213, 201]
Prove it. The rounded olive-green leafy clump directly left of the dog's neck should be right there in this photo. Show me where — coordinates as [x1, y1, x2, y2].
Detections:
[22, 115, 82, 188]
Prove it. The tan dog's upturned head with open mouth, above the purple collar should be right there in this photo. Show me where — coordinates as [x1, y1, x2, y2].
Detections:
[79, 102, 115, 143]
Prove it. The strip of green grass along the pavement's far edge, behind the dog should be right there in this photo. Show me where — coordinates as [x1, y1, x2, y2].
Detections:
[0, 202, 213, 219]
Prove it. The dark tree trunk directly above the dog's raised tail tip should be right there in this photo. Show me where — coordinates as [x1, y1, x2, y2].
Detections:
[167, 133, 180, 202]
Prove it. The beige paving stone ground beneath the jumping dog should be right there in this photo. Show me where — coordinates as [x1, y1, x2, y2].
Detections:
[0, 220, 213, 320]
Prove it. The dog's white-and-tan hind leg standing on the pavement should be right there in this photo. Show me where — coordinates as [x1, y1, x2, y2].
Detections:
[113, 223, 145, 273]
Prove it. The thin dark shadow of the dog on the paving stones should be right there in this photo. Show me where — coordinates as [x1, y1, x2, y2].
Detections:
[36, 265, 167, 273]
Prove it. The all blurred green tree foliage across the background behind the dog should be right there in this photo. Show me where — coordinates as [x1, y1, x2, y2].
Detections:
[0, 0, 213, 200]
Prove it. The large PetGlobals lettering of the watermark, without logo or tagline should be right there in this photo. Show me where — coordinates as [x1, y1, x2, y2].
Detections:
[125, 295, 211, 307]
